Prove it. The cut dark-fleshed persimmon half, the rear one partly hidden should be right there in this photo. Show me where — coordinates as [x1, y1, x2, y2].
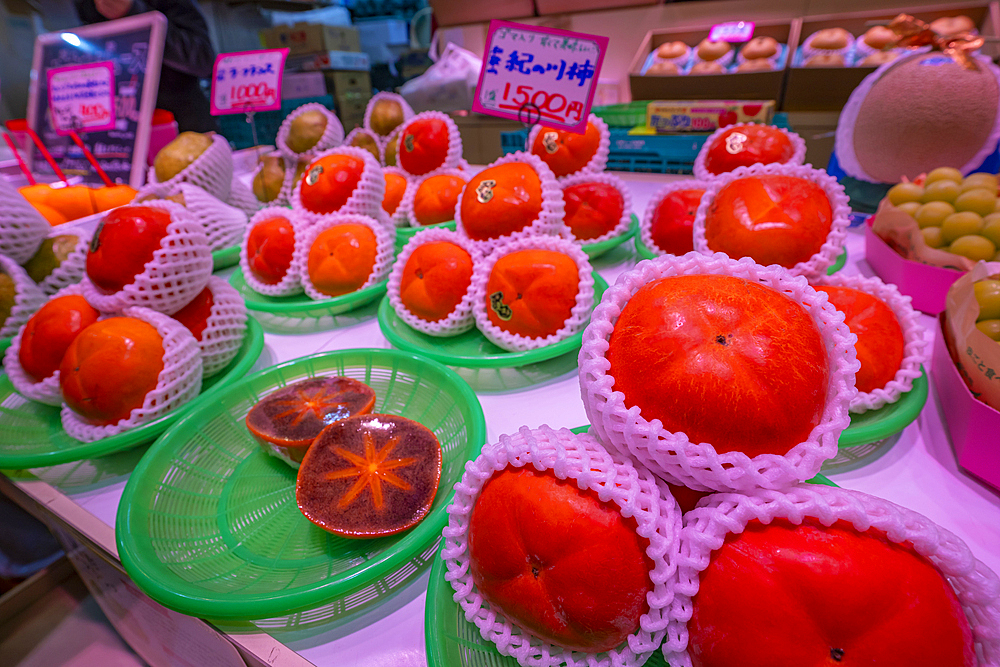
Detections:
[246, 377, 375, 468]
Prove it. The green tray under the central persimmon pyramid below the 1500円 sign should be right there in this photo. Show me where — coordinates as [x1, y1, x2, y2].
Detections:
[378, 272, 608, 368]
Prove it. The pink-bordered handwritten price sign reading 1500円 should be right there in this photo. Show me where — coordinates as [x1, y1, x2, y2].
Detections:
[472, 21, 608, 134]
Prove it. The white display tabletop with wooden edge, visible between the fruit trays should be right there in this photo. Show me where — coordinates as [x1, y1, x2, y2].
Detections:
[0, 174, 1000, 667]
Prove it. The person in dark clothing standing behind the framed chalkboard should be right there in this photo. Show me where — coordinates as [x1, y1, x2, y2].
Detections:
[74, 0, 219, 132]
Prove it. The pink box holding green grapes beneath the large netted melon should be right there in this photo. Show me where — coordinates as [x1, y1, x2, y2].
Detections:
[865, 216, 965, 315]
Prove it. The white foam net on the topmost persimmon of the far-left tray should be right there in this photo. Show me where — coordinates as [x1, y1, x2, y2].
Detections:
[82, 200, 212, 315]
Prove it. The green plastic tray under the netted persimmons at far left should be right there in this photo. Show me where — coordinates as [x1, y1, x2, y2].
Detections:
[0, 318, 264, 469]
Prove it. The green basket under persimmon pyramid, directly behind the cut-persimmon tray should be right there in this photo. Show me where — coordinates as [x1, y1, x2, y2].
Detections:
[229, 268, 389, 333]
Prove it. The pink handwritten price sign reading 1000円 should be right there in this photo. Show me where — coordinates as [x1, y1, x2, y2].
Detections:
[211, 48, 288, 116]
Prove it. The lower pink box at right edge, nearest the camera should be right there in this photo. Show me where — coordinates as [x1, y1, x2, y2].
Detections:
[931, 314, 1000, 489]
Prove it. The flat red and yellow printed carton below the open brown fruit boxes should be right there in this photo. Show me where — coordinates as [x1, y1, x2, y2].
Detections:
[646, 100, 774, 134]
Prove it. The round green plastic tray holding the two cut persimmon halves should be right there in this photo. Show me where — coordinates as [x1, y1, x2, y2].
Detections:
[115, 349, 486, 620]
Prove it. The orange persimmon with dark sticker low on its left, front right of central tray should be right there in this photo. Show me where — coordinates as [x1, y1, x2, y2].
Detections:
[486, 249, 580, 338]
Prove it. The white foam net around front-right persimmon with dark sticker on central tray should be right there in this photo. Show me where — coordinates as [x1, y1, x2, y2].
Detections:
[472, 236, 594, 352]
